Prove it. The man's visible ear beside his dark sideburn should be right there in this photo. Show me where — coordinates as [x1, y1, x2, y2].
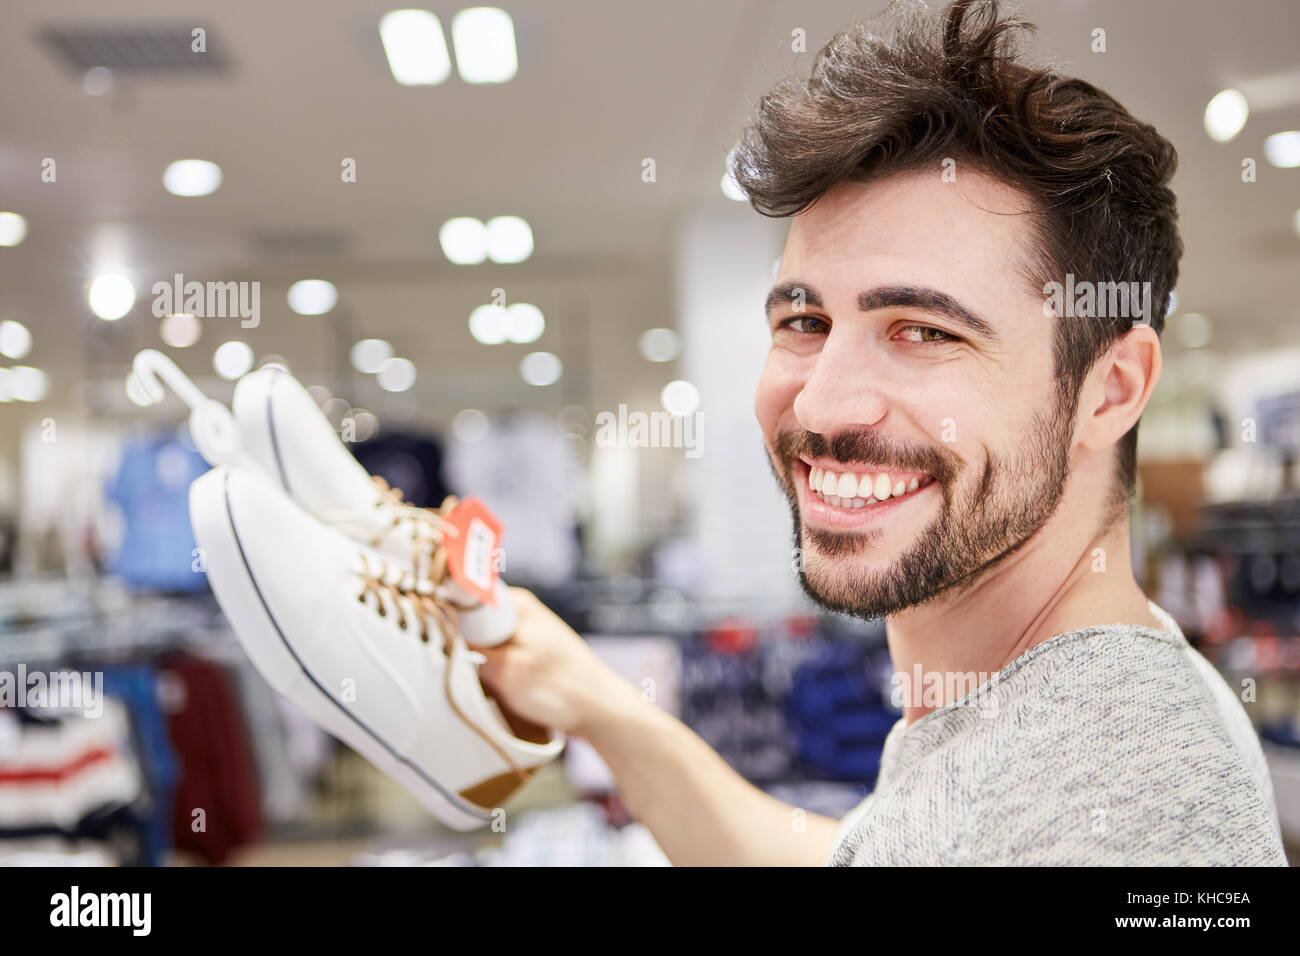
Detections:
[1079, 325, 1162, 449]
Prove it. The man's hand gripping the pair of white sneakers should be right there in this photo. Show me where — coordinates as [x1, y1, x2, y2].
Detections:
[477, 588, 640, 736]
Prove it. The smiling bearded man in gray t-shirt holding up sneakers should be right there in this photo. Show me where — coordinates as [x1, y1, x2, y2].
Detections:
[482, 1, 1284, 865]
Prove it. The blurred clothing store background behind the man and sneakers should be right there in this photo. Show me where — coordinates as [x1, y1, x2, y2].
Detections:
[0, 0, 1300, 865]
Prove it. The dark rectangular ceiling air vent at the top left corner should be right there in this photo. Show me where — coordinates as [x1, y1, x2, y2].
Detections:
[40, 23, 229, 75]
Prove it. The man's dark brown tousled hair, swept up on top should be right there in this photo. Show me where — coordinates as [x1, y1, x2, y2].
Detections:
[732, 0, 1183, 497]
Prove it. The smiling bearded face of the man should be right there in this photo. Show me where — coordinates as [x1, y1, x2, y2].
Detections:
[754, 172, 1074, 618]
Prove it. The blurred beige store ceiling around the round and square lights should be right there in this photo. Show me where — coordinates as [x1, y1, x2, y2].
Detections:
[0, 0, 1300, 429]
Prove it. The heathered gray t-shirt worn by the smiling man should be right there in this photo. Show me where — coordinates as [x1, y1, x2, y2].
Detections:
[829, 604, 1287, 866]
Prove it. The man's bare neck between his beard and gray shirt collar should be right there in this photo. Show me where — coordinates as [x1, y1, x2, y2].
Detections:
[887, 493, 1160, 724]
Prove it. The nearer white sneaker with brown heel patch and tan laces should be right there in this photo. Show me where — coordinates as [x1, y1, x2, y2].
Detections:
[190, 462, 564, 830]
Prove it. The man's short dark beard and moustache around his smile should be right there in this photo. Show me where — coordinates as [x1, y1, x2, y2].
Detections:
[770, 401, 1074, 619]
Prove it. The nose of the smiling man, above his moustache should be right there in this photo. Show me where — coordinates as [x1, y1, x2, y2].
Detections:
[794, 332, 888, 434]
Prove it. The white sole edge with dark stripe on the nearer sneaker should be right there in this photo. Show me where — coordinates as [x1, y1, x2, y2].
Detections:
[190, 468, 491, 831]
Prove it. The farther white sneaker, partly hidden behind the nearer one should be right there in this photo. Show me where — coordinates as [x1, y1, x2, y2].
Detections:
[233, 367, 516, 646]
